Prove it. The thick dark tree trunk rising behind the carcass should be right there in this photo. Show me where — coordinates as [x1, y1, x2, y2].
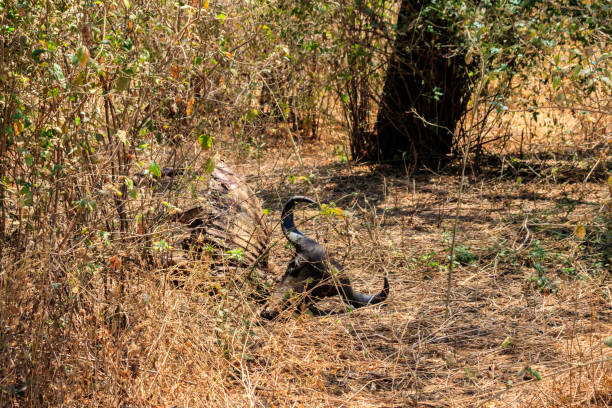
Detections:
[367, 0, 469, 168]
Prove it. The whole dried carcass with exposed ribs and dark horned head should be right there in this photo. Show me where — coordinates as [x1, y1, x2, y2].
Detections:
[157, 162, 389, 318]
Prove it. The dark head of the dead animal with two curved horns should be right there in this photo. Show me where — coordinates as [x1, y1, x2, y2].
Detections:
[262, 196, 389, 319]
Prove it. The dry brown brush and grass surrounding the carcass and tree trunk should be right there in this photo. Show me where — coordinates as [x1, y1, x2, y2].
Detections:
[0, 0, 612, 408]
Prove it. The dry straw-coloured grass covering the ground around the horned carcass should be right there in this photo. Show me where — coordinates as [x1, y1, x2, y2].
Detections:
[0, 129, 612, 407]
